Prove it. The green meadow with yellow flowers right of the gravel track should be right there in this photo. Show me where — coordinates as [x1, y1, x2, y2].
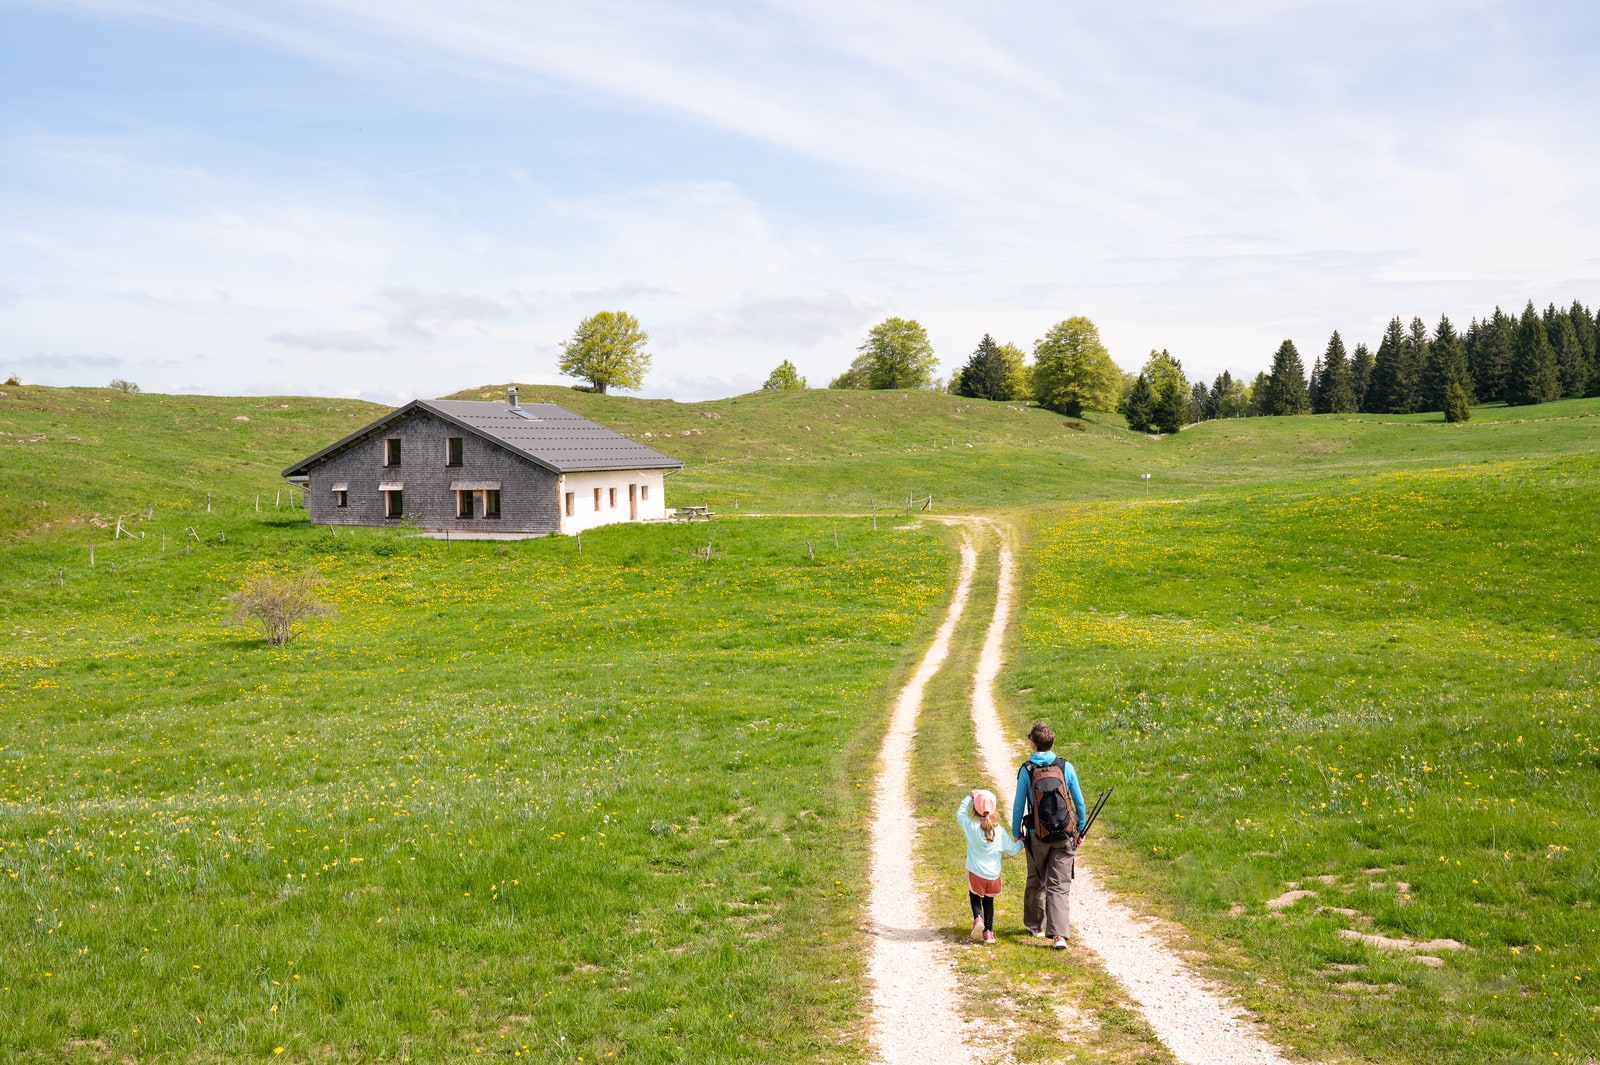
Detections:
[1010, 450, 1600, 1062]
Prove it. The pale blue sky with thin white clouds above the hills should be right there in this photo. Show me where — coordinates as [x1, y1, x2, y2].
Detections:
[0, 0, 1600, 403]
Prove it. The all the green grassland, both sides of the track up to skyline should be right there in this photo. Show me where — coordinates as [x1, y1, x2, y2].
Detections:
[0, 385, 1600, 1062]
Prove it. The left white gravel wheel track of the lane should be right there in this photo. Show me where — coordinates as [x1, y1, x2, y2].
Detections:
[867, 537, 978, 1065]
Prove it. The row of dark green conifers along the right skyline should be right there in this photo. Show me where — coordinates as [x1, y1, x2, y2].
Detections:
[1118, 301, 1600, 433]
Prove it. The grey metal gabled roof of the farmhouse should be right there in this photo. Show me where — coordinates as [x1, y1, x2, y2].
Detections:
[283, 400, 683, 477]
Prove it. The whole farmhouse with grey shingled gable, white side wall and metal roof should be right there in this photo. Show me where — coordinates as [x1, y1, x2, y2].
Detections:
[283, 387, 683, 537]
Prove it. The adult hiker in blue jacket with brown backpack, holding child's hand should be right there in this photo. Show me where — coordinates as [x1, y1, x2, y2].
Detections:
[1011, 721, 1085, 948]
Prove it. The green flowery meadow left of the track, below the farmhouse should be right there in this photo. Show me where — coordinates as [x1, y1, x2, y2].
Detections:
[0, 495, 950, 1062]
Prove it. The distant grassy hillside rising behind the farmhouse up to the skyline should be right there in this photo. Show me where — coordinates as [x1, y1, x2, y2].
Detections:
[0, 375, 1600, 539]
